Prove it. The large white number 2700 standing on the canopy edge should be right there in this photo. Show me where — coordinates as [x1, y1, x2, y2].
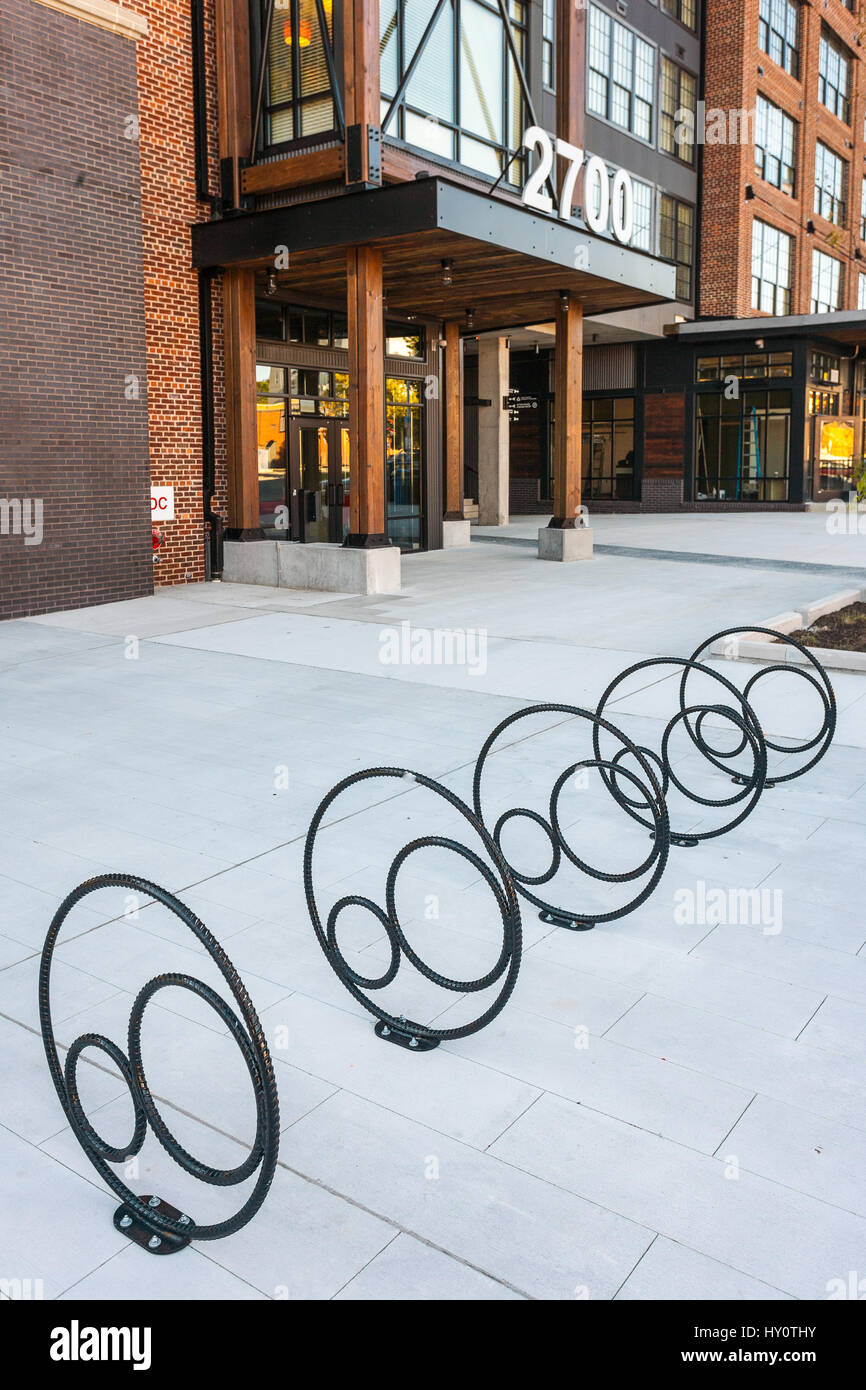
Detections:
[523, 125, 634, 245]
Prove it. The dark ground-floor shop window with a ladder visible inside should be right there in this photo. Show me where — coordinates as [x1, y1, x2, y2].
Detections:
[695, 389, 791, 502]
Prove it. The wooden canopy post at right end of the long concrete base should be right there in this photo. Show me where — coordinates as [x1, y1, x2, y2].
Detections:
[346, 246, 389, 546]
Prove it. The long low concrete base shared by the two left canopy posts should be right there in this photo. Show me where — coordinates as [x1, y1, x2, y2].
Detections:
[222, 541, 400, 594]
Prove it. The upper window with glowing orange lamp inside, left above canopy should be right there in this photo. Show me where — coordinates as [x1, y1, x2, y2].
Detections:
[261, 0, 335, 145]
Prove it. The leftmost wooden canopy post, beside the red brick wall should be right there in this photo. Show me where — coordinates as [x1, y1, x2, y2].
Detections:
[222, 267, 263, 541]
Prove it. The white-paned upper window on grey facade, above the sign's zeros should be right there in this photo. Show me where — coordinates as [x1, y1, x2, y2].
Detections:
[587, 6, 656, 142]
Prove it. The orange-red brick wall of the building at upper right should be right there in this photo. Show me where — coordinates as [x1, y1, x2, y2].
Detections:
[699, 0, 866, 317]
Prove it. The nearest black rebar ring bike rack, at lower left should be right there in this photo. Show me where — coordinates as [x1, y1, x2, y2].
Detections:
[39, 874, 279, 1255]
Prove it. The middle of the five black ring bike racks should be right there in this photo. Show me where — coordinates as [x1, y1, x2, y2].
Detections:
[473, 703, 670, 931]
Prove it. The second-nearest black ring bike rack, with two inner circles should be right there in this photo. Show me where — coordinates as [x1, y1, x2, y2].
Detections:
[303, 767, 523, 1052]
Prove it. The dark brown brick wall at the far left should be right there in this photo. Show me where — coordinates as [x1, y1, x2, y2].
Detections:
[0, 0, 153, 617]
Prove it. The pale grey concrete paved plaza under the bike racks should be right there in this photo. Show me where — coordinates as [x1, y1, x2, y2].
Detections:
[0, 516, 866, 1300]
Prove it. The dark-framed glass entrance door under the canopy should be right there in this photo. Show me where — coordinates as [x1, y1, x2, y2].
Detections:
[289, 420, 349, 543]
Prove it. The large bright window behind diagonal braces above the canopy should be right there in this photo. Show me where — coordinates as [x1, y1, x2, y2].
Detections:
[379, 0, 525, 185]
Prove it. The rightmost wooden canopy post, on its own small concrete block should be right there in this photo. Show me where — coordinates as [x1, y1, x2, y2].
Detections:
[549, 296, 584, 530]
